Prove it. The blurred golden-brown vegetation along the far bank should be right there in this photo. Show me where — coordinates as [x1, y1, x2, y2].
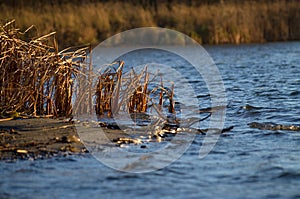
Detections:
[0, 0, 300, 48]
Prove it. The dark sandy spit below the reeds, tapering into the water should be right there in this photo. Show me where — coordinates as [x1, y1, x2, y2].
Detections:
[0, 118, 233, 161]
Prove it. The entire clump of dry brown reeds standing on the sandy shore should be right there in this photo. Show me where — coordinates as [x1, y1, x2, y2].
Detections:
[0, 20, 175, 123]
